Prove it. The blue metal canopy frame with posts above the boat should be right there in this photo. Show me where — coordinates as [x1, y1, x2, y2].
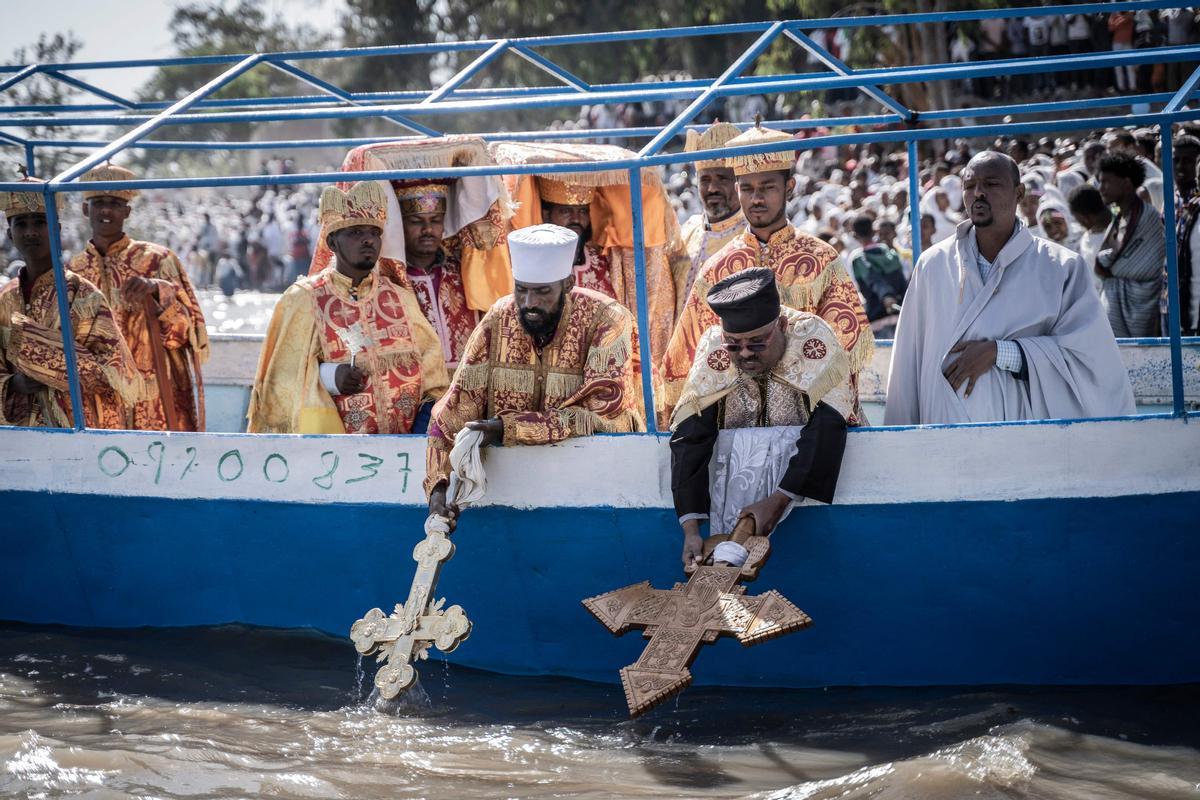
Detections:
[0, 0, 1200, 432]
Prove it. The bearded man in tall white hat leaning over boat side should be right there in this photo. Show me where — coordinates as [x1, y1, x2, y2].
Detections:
[425, 224, 646, 525]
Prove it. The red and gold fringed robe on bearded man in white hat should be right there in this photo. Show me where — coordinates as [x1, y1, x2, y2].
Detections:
[425, 288, 646, 493]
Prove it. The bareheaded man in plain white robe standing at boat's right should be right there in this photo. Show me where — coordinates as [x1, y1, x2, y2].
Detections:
[884, 151, 1134, 425]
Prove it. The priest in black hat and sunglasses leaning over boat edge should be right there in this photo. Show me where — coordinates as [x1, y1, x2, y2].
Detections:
[671, 267, 853, 567]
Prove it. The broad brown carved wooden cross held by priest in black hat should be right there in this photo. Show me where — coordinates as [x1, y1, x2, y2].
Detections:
[583, 536, 812, 716]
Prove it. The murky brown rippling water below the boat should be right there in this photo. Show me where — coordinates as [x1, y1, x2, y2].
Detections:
[0, 625, 1200, 800]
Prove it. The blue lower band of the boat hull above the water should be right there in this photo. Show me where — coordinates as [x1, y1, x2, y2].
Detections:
[0, 492, 1200, 686]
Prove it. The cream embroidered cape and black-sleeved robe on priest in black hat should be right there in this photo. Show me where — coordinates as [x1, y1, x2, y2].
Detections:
[671, 308, 852, 533]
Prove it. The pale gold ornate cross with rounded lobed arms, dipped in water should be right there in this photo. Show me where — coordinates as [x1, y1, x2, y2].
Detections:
[350, 517, 470, 700]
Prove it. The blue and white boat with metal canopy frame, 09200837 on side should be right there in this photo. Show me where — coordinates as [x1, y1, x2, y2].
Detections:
[0, 0, 1200, 687]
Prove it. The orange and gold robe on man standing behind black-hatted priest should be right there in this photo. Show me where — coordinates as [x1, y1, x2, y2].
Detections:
[662, 225, 875, 426]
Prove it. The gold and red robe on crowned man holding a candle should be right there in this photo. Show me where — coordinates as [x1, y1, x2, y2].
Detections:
[247, 259, 449, 433]
